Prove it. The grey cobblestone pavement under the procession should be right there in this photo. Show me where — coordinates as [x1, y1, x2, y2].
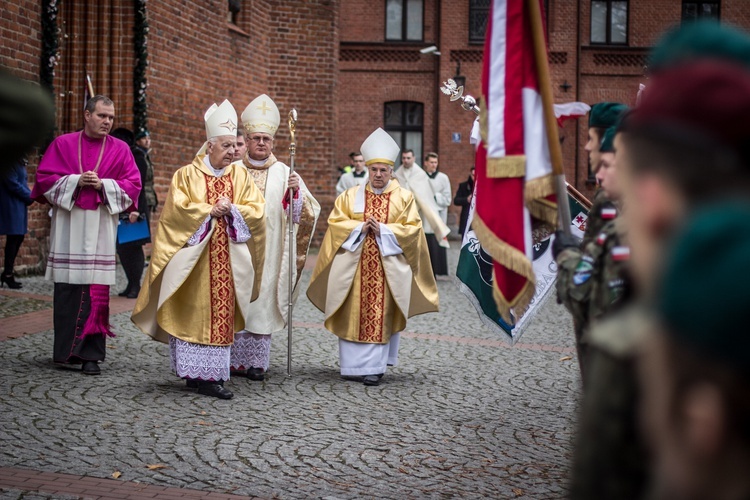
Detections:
[0, 250, 580, 499]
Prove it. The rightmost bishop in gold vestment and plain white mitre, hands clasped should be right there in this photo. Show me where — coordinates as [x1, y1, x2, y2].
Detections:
[307, 129, 438, 385]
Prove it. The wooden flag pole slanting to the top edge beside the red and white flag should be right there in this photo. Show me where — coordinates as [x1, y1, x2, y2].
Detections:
[527, 0, 571, 235]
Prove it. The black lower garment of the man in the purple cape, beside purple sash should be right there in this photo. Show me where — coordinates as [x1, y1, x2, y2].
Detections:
[52, 283, 107, 363]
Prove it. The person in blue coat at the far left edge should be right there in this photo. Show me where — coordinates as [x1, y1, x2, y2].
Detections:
[0, 160, 31, 288]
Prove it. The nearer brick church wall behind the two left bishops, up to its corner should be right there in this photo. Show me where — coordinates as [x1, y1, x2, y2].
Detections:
[0, 0, 338, 272]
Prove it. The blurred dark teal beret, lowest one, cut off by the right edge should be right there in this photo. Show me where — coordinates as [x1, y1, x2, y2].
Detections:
[656, 201, 750, 374]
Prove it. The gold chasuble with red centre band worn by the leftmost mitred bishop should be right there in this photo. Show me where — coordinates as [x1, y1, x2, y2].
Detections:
[131, 156, 265, 345]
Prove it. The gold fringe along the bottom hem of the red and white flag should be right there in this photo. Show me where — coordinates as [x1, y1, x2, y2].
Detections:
[471, 214, 536, 323]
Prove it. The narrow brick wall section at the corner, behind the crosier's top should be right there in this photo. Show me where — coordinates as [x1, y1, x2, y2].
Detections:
[268, 0, 339, 244]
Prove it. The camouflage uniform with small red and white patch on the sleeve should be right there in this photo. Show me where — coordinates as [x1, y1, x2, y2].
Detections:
[557, 216, 630, 376]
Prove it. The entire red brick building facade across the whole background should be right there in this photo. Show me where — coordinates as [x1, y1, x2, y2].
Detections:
[0, 0, 750, 272]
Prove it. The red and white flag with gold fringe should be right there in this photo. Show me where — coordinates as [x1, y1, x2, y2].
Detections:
[472, 0, 557, 322]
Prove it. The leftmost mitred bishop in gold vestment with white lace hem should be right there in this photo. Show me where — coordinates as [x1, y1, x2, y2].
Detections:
[132, 101, 264, 399]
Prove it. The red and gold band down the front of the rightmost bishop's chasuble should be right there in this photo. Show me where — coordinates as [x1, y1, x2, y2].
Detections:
[359, 191, 391, 343]
